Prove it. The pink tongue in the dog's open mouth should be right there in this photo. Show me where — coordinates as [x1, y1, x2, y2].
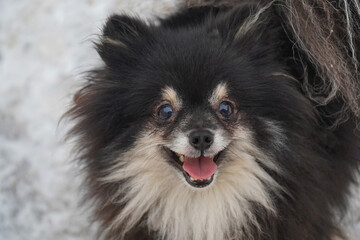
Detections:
[183, 155, 217, 179]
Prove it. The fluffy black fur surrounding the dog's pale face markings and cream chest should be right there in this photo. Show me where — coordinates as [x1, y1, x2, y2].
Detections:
[69, 3, 358, 240]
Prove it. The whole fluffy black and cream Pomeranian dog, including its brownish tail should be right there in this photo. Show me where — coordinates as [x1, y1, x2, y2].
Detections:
[68, 0, 359, 240]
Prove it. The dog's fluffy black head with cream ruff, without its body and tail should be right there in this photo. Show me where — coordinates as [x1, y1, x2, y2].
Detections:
[72, 6, 320, 239]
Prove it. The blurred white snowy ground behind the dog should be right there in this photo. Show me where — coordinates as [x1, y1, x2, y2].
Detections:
[0, 0, 360, 240]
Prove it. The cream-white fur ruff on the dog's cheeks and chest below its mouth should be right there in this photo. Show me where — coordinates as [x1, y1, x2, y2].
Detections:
[101, 124, 280, 240]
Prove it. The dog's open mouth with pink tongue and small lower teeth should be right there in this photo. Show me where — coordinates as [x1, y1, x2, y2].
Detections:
[165, 147, 221, 188]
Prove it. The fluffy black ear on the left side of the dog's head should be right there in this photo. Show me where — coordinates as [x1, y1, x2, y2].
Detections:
[96, 15, 151, 68]
